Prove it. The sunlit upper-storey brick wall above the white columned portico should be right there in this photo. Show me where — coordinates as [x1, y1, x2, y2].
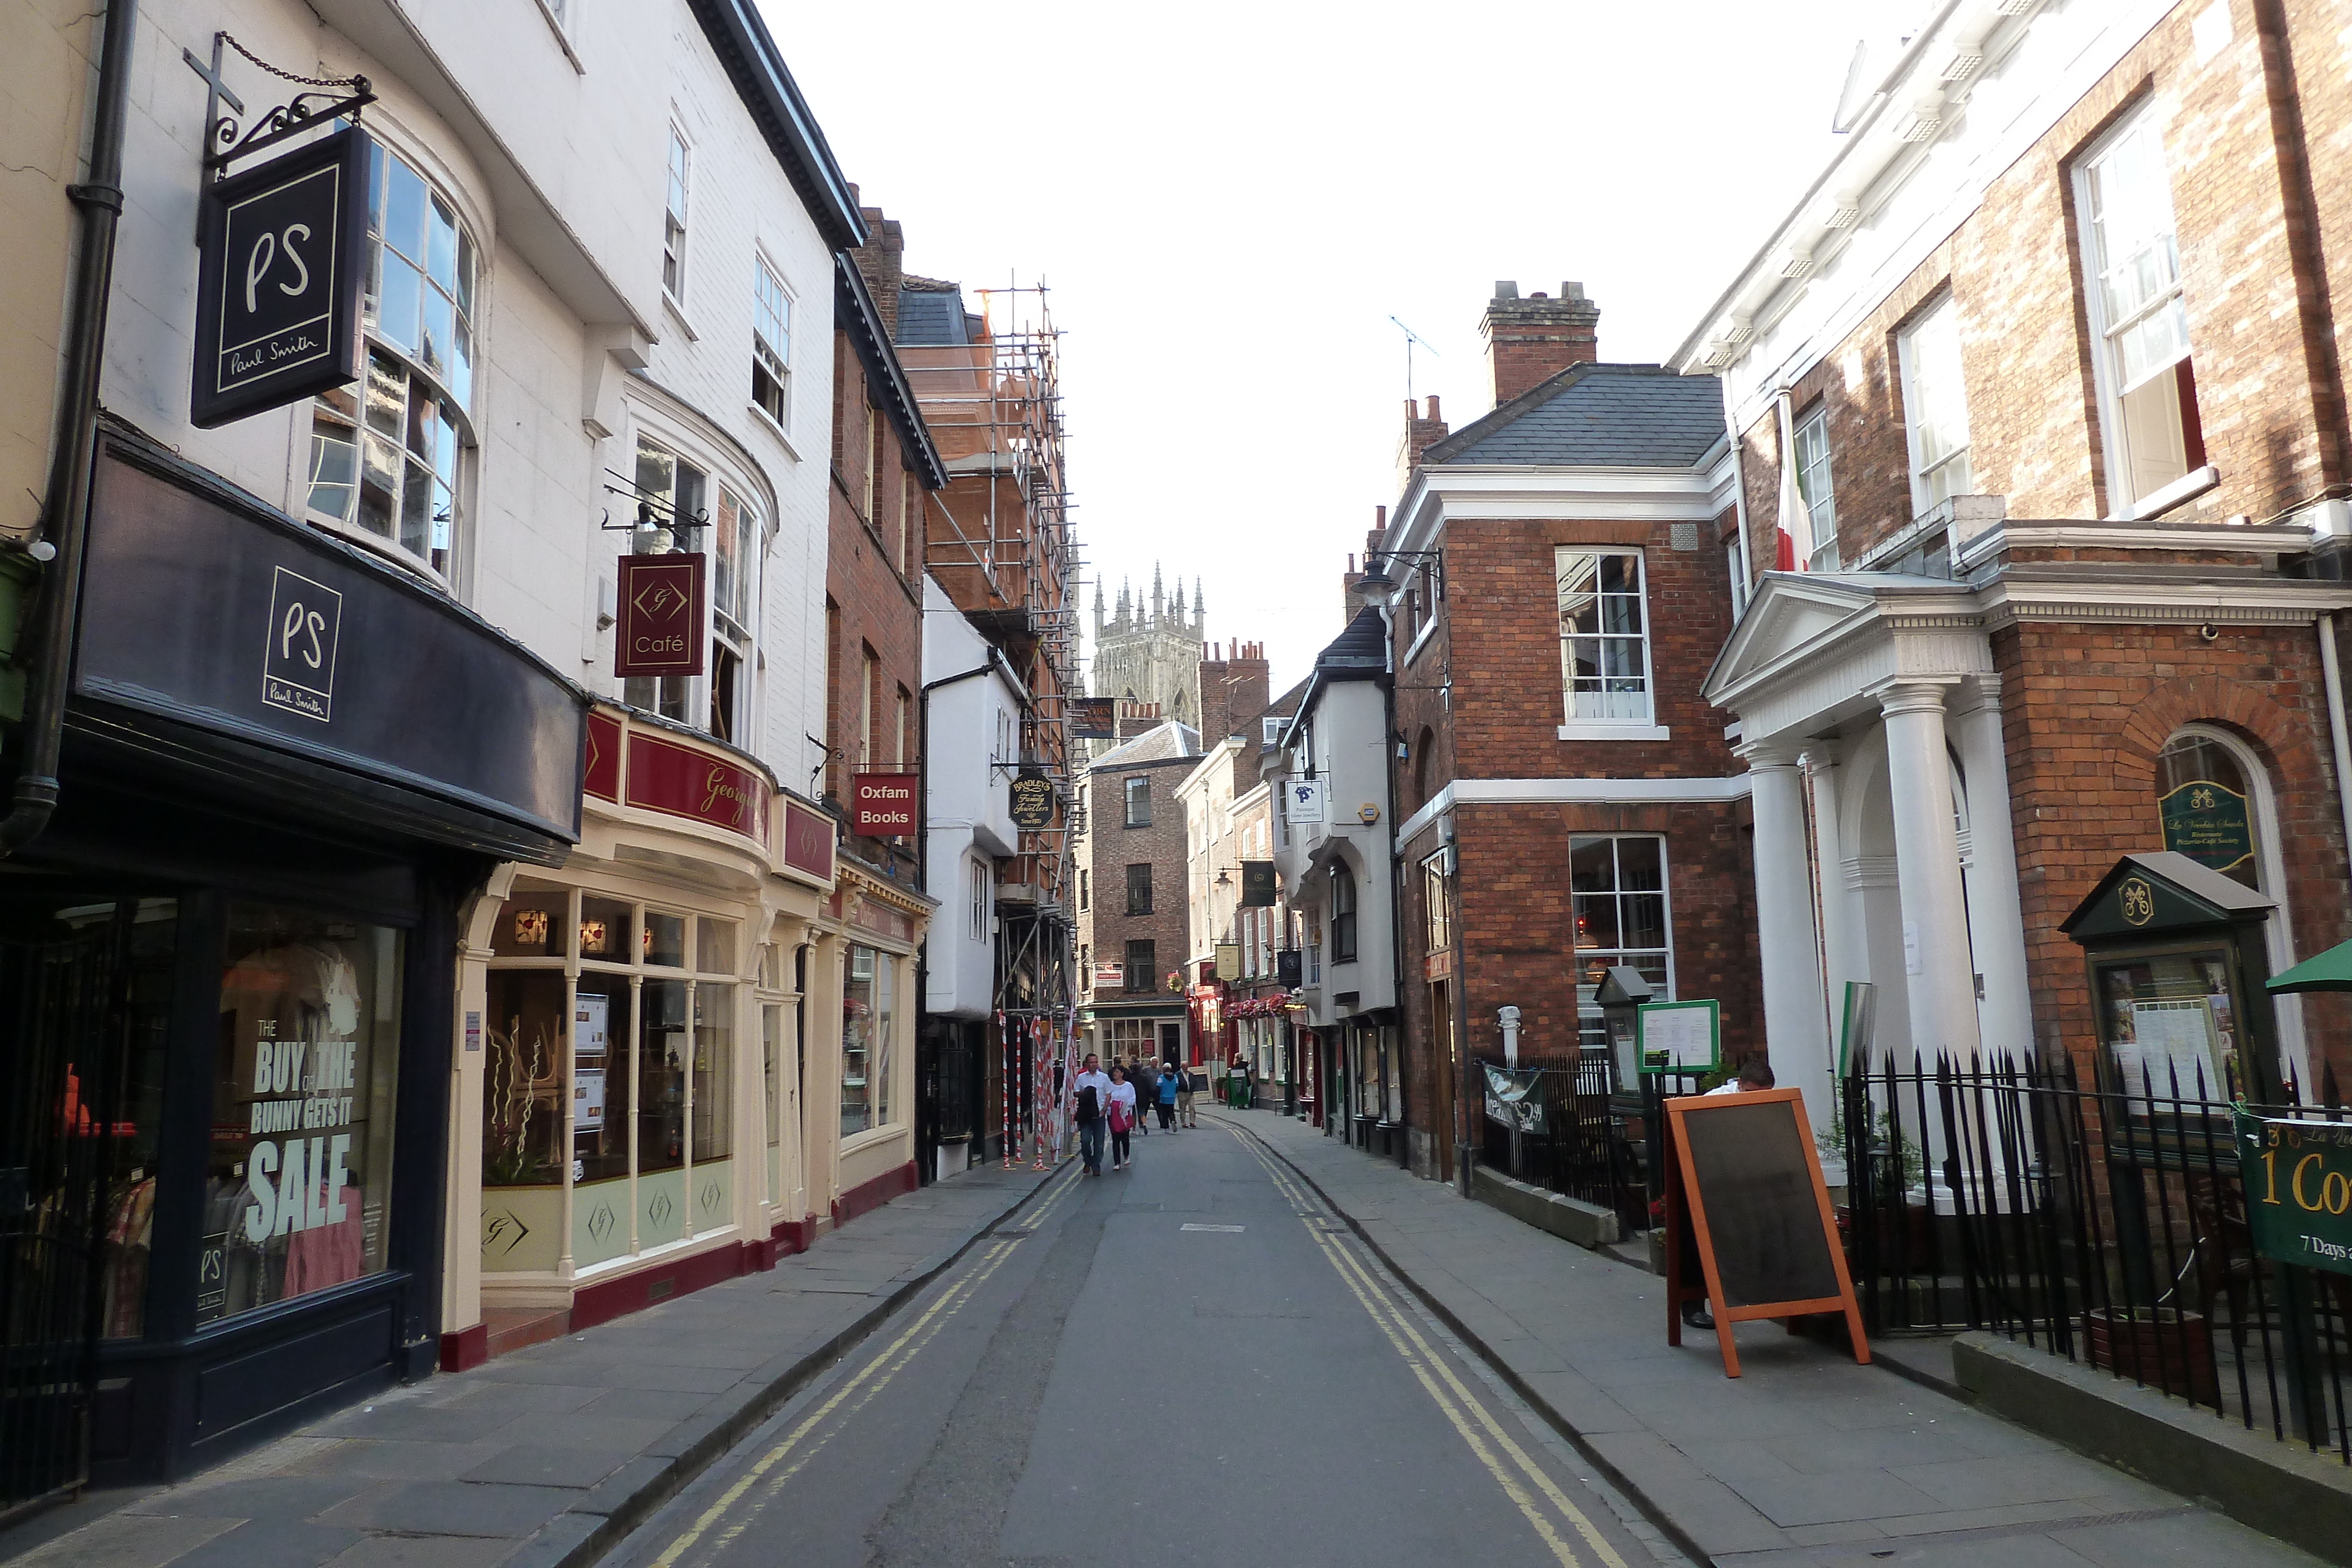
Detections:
[1740, 0, 2352, 594]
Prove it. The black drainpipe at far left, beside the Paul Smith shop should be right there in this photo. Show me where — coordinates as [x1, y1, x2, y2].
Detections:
[0, 0, 139, 858]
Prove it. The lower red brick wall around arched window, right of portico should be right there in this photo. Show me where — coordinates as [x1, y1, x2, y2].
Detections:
[1992, 623, 2352, 1079]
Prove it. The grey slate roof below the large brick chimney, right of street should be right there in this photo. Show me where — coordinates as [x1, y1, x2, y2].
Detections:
[1421, 365, 1724, 468]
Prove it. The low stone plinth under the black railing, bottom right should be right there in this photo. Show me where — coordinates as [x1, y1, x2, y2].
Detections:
[1952, 1333, 2352, 1566]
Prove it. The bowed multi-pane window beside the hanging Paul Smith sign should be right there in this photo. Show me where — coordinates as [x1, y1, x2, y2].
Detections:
[308, 141, 480, 576]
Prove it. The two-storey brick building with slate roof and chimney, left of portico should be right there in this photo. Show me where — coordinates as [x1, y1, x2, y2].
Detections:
[1355, 282, 1759, 1175]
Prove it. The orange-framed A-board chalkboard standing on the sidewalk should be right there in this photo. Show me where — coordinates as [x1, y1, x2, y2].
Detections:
[1665, 1088, 1870, 1378]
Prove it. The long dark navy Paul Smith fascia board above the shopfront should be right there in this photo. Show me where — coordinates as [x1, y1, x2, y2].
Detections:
[73, 435, 588, 860]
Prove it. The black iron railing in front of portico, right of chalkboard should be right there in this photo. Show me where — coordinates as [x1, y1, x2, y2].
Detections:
[1825, 1060, 2352, 1465]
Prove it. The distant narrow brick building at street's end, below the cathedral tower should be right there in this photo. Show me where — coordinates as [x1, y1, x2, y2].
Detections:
[1077, 720, 1200, 1060]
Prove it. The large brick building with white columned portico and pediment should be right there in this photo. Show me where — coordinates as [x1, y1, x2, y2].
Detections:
[1675, 0, 2352, 1128]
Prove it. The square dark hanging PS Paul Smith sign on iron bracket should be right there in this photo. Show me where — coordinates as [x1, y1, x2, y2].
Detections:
[188, 125, 369, 430]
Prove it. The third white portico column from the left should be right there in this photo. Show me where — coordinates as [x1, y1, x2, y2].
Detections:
[1872, 682, 1978, 1065]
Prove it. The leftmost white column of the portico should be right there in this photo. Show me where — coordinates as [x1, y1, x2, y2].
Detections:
[1738, 743, 1835, 1131]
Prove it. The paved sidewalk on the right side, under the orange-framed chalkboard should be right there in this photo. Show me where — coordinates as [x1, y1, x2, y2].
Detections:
[1204, 1109, 2317, 1568]
